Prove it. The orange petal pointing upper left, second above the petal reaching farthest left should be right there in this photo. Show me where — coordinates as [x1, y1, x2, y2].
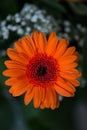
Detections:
[7, 48, 29, 64]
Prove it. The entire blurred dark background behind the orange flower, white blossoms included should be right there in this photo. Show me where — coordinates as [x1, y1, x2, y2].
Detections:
[0, 0, 87, 130]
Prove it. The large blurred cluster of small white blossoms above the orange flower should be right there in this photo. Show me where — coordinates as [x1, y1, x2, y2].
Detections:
[0, 4, 58, 40]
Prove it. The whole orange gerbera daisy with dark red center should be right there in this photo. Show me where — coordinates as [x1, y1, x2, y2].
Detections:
[3, 32, 81, 109]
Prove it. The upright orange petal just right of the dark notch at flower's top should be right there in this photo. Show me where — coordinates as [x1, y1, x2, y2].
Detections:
[45, 32, 58, 56]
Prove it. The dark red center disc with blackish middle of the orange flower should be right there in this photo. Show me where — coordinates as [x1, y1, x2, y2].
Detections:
[26, 54, 58, 87]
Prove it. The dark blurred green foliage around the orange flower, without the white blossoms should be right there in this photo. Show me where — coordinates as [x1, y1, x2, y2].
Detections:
[0, 0, 87, 130]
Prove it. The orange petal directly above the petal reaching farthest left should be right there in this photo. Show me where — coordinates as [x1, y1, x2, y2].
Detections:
[4, 60, 26, 70]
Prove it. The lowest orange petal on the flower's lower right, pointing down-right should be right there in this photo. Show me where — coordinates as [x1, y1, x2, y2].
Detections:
[54, 84, 74, 97]
